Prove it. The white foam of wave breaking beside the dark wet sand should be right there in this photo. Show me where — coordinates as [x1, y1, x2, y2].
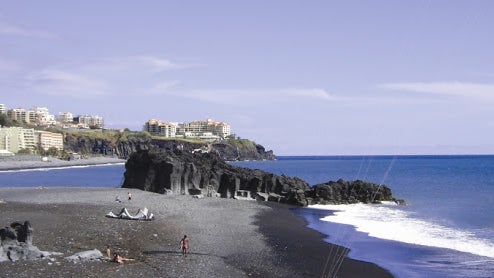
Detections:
[310, 203, 494, 258]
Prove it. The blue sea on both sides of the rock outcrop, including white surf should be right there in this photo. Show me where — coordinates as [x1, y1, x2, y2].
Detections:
[0, 156, 494, 277]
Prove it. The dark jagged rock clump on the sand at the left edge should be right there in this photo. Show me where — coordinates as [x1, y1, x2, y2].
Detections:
[0, 221, 62, 262]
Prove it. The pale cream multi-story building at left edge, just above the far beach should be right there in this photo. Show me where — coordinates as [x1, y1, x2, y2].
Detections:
[0, 127, 36, 153]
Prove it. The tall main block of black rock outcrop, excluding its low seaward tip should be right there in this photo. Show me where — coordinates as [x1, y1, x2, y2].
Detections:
[122, 150, 310, 205]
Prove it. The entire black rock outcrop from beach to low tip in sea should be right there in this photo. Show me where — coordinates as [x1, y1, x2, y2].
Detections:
[122, 150, 400, 206]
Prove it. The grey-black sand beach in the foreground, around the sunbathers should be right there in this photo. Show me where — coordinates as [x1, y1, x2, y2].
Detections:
[0, 188, 392, 277]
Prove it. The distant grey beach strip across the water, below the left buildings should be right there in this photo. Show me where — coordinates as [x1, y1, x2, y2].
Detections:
[0, 156, 126, 171]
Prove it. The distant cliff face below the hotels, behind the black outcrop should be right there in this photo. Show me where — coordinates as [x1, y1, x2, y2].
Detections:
[64, 134, 276, 161]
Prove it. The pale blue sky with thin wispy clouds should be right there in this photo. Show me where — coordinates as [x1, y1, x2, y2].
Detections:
[0, 0, 494, 155]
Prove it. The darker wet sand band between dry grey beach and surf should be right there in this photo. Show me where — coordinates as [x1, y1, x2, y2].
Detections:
[258, 203, 394, 278]
